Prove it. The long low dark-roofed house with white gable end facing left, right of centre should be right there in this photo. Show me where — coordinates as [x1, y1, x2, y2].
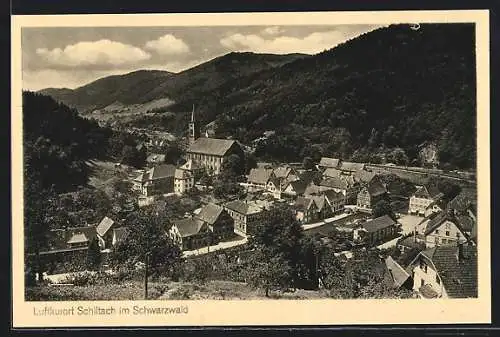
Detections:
[353, 215, 398, 245]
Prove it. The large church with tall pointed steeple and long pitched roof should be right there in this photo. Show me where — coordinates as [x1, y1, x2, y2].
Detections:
[186, 107, 243, 175]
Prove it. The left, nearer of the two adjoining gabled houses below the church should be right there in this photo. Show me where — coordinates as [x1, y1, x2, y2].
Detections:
[168, 217, 212, 250]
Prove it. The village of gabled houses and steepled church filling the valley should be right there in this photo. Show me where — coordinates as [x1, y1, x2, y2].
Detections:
[36, 108, 477, 298]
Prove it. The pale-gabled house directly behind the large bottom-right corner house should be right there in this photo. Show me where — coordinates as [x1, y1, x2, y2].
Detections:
[424, 209, 469, 248]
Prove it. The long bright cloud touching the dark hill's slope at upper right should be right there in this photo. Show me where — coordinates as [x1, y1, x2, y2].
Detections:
[220, 28, 380, 54]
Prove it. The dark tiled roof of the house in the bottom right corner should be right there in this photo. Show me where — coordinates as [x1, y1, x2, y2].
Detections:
[420, 245, 477, 298]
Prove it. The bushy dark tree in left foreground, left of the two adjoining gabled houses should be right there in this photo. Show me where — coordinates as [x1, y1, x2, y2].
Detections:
[112, 209, 181, 275]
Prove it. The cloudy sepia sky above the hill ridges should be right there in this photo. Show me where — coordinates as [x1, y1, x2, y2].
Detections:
[21, 25, 379, 90]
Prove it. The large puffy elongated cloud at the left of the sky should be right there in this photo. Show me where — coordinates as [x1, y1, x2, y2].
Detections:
[36, 40, 151, 69]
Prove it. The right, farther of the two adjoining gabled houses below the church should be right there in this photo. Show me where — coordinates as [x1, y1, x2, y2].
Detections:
[195, 203, 234, 243]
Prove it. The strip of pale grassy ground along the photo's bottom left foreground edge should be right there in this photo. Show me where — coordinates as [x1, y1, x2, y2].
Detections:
[26, 281, 328, 301]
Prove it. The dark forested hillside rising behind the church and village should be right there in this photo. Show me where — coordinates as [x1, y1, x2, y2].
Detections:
[40, 24, 476, 168]
